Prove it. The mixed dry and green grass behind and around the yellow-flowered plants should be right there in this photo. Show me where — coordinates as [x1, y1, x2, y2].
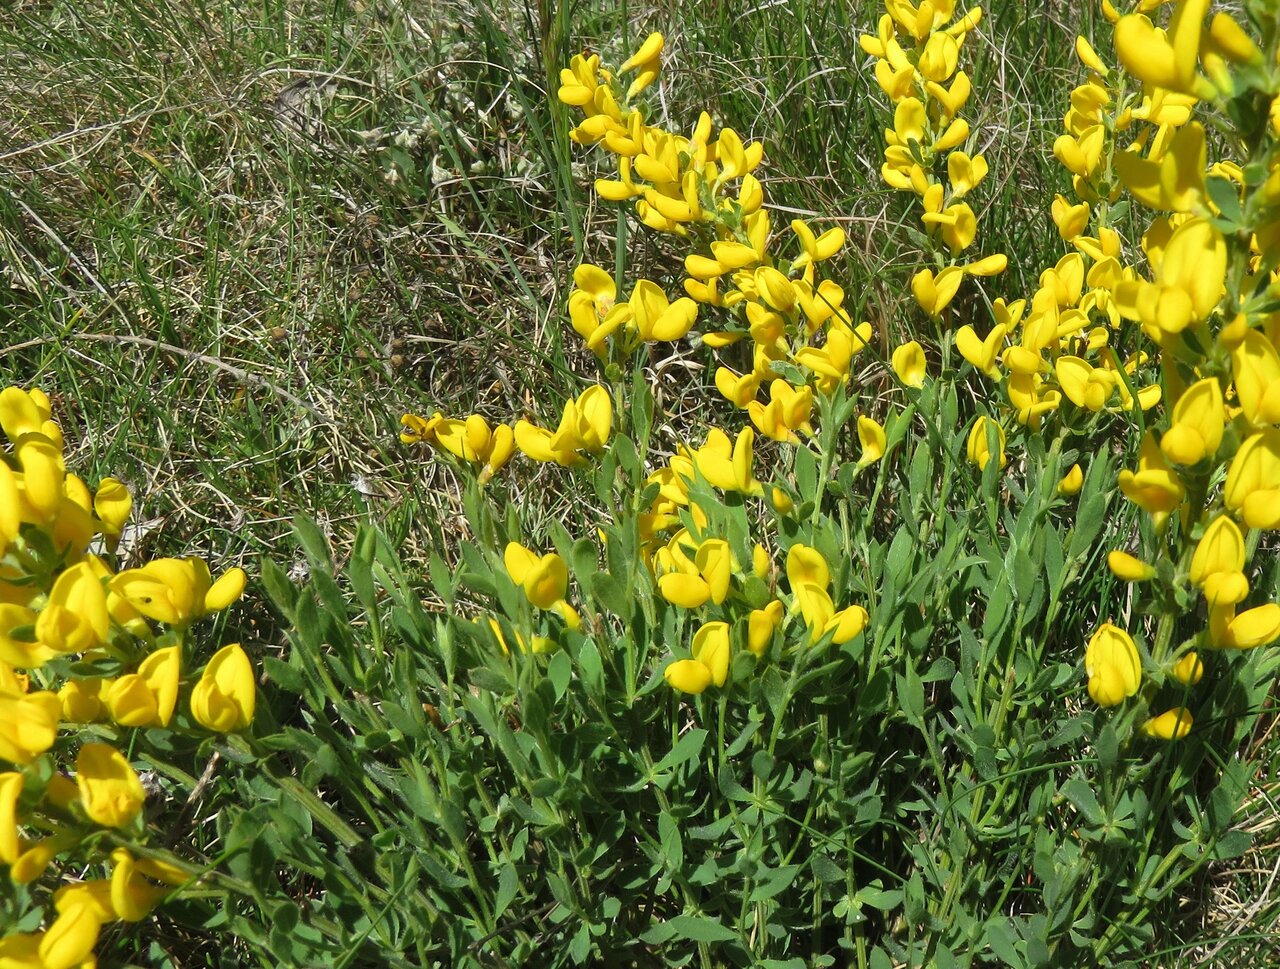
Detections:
[0, 0, 1280, 965]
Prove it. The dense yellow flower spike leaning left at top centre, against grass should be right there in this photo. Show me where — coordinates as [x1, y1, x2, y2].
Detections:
[559, 33, 890, 443]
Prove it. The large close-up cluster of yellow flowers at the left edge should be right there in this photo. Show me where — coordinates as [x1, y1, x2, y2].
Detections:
[0, 387, 256, 969]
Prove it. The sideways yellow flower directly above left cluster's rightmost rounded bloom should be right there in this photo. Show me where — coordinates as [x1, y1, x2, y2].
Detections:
[110, 557, 246, 626]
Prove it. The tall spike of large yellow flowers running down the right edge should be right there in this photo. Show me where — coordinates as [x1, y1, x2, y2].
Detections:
[1085, 0, 1280, 739]
